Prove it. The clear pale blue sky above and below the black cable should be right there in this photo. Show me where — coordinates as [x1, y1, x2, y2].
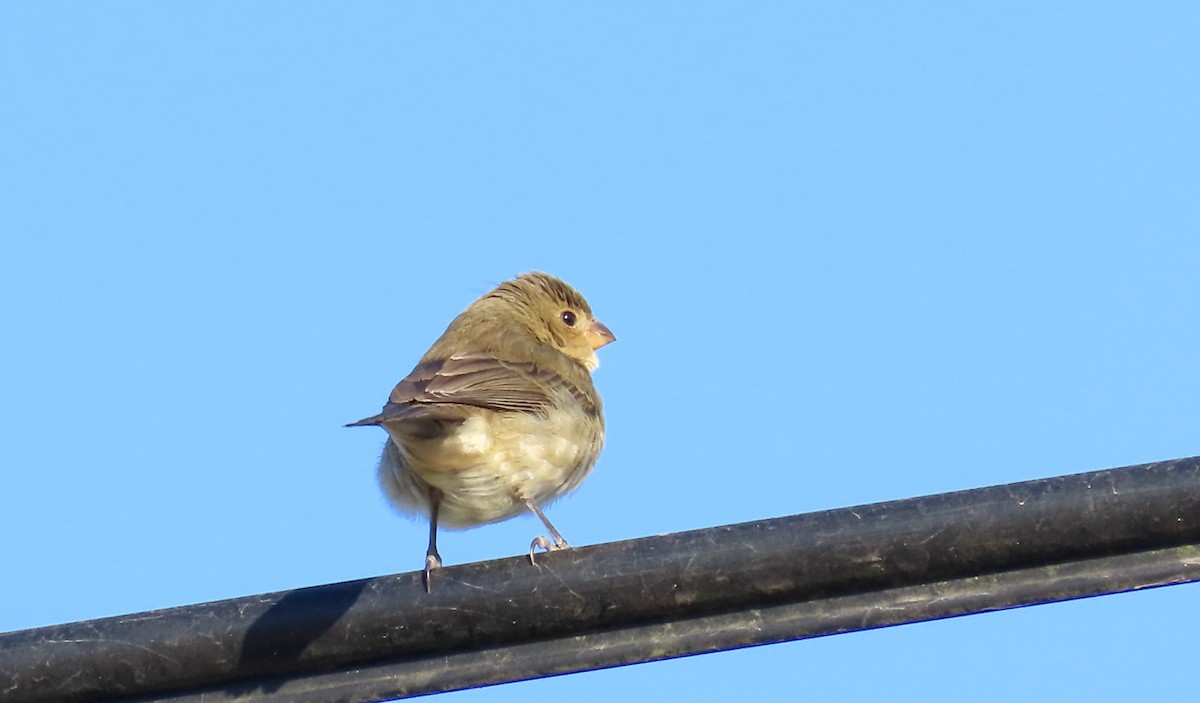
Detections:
[0, 1, 1200, 703]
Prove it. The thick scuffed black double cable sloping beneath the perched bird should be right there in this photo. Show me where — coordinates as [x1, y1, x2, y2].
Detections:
[0, 457, 1200, 703]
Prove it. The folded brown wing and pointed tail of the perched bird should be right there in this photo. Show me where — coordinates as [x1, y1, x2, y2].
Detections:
[354, 354, 590, 426]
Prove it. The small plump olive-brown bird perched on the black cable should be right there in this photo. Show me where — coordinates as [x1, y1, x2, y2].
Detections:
[347, 271, 616, 591]
